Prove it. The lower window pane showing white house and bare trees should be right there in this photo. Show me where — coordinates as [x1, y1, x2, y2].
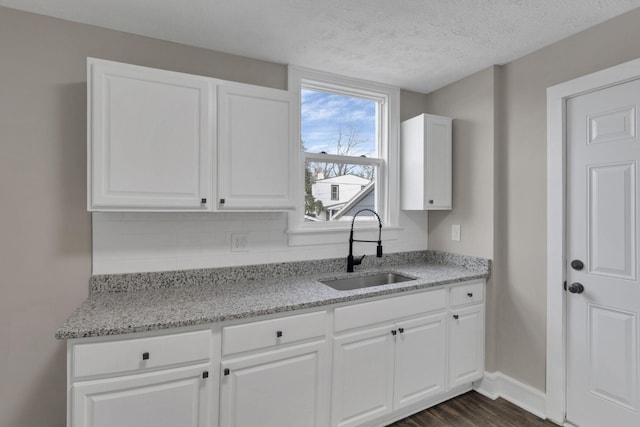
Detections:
[304, 160, 377, 222]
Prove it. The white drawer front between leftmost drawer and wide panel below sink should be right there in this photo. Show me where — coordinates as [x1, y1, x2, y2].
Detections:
[222, 311, 327, 356]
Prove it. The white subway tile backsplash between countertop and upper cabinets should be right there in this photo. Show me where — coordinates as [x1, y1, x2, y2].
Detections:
[92, 212, 427, 275]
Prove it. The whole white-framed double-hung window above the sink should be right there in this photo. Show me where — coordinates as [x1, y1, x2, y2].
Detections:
[289, 67, 399, 244]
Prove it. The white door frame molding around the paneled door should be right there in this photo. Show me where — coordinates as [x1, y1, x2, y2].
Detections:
[546, 58, 640, 425]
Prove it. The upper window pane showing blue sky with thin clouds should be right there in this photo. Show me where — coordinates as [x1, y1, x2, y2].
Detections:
[301, 89, 378, 157]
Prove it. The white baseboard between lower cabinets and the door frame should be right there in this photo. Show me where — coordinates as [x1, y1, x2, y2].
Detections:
[473, 372, 547, 419]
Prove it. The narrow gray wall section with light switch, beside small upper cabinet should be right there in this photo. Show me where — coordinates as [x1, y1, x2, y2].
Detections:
[425, 67, 500, 372]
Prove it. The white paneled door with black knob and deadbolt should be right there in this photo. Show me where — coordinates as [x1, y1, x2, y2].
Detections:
[566, 80, 640, 427]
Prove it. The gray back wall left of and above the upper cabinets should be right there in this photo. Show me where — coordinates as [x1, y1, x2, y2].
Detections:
[0, 7, 426, 427]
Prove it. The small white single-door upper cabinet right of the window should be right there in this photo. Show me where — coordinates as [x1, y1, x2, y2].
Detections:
[400, 114, 452, 210]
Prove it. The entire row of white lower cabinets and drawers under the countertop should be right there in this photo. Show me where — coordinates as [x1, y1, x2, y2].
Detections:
[68, 280, 485, 427]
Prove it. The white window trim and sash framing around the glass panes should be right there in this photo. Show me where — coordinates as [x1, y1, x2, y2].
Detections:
[287, 65, 400, 246]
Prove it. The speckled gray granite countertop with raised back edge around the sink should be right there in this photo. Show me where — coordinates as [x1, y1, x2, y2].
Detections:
[56, 251, 491, 339]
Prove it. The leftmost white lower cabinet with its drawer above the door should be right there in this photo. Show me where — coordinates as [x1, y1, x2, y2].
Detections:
[67, 330, 214, 427]
